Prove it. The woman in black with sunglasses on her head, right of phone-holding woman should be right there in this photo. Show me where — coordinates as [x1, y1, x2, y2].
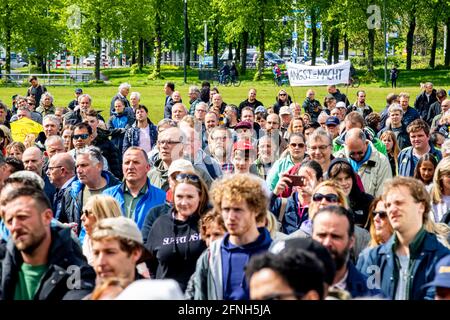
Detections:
[327, 158, 373, 227]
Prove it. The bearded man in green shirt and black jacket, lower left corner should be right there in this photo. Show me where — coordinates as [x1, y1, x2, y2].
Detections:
[0, 186, 95, 301]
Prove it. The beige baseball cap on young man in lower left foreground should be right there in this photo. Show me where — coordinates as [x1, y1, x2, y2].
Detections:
[92, 217, 144, 246]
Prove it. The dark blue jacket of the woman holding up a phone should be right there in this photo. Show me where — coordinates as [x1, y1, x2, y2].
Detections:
[270, 192, 308, 234]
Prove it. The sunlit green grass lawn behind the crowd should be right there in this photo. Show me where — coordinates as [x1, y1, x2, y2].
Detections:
[0, 67, 450, 122]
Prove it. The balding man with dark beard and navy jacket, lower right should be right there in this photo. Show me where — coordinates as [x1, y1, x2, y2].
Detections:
[312, 206, 380, 298]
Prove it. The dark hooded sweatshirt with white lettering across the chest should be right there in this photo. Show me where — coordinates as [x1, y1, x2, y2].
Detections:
[146, 211, 206, 292]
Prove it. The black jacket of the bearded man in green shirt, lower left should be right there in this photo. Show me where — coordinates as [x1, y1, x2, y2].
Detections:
[0, 227, 95, 301]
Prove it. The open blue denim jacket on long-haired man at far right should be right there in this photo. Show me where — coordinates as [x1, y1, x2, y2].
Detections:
[356, 231, 450, 300]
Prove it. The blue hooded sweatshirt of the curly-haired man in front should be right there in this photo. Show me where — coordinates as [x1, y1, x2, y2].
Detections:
[220, 228, 272, 300]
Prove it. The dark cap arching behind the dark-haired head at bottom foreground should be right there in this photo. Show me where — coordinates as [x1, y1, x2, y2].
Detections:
[269, 238, 336, 285]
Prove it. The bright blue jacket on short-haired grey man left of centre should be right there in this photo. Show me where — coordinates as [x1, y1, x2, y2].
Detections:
[103, 178, 166, 230]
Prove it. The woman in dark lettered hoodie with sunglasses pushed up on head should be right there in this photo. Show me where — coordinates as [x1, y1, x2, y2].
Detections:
[145, 171, 209, 292]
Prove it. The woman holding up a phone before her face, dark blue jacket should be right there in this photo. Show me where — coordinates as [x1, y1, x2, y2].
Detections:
[270, 160, 323, 234]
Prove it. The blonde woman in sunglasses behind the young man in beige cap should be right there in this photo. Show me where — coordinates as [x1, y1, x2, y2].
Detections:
[81, 195, 122, 265]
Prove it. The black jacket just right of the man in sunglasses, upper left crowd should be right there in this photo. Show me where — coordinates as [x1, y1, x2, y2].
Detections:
[91, 128, 123, 180]
